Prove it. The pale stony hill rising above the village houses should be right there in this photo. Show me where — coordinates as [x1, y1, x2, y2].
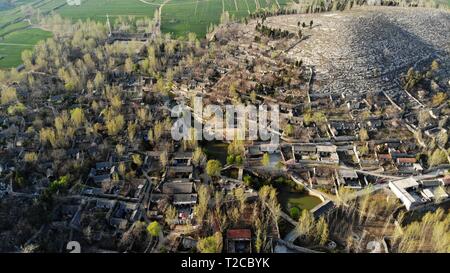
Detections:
[266, 7, 450, 98]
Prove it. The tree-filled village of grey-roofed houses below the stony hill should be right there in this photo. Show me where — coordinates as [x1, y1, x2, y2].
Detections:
[0, 3, 450, 253]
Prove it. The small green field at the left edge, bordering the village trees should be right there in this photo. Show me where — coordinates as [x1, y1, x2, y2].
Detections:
[0, 28, 52, 68]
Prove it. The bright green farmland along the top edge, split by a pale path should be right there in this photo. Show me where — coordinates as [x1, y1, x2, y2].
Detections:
[57, 0, 291, 36]
